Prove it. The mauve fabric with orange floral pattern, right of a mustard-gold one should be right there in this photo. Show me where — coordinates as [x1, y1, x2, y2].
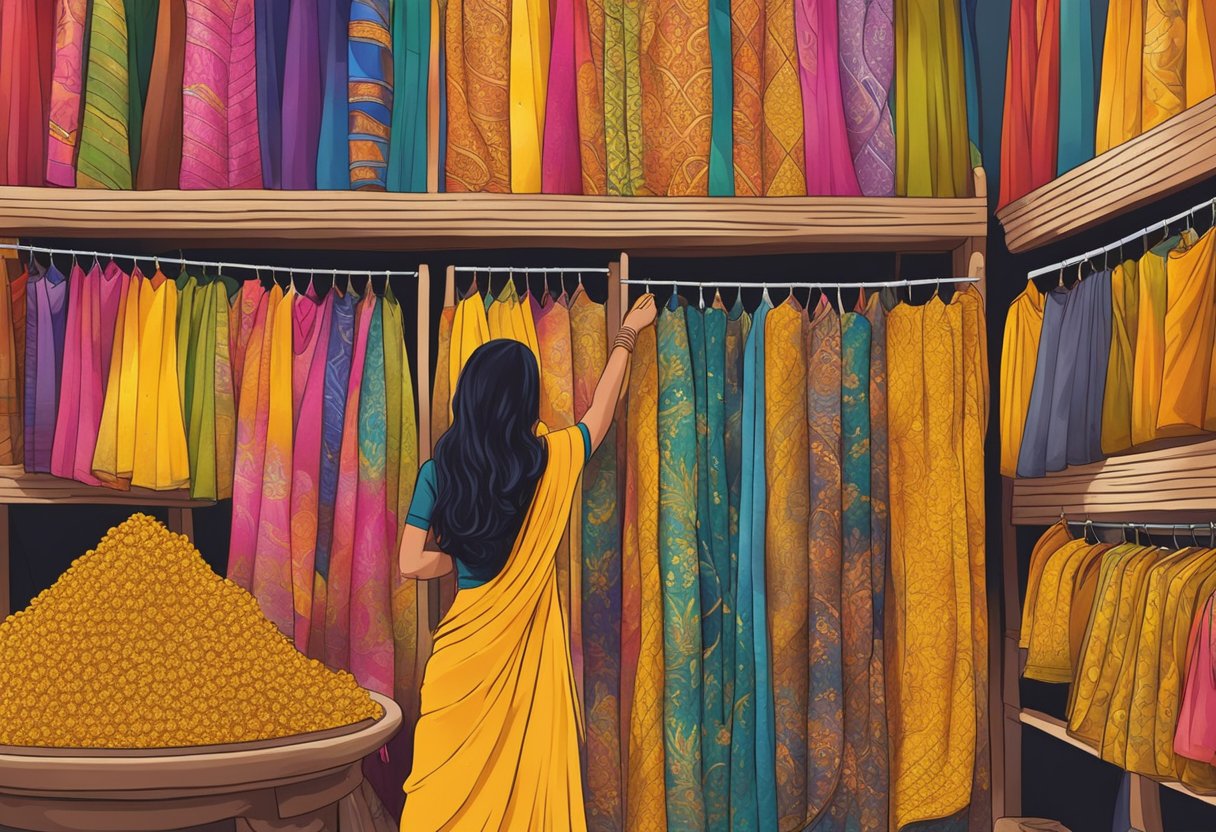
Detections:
[804, 296, 844, 823]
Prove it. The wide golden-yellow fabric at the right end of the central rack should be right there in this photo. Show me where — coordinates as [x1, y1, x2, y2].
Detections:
[886, 288, 987, 828]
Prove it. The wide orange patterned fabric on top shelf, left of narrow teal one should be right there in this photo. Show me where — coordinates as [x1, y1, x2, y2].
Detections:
[640, 0, 714, 196]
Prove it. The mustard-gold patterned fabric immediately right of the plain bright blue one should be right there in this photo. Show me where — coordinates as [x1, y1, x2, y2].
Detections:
[764, 300, 811, 830]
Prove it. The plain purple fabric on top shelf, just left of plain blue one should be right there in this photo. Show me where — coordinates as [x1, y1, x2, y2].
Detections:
[282, 0, 322, 191]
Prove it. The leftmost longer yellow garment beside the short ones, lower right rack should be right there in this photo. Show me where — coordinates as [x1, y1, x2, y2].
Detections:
[1069, 546, 1162, 759]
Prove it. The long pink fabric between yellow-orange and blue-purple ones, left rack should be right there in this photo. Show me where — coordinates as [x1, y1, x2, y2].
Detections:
[292, 292, 334, 654]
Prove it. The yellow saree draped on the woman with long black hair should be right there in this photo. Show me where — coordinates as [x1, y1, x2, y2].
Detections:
[401, 427, 586, 832]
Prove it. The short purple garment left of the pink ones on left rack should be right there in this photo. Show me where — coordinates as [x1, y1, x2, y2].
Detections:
[26, 264, 68, 473]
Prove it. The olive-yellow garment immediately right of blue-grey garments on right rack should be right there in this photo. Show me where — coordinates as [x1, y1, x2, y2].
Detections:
[1102, 260, 1139, 454]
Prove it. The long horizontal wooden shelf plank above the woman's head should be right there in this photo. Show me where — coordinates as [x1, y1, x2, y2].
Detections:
[0, 187, 987, 255]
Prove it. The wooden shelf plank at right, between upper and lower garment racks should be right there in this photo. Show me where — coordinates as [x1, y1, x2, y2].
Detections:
[1012, 437, 1216, 525]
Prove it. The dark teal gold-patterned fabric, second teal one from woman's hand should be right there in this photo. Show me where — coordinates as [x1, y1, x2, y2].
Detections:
[687, 309, 734, 832]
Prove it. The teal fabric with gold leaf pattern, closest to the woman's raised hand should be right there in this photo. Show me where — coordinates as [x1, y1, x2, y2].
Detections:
[657, 309, 705, 830]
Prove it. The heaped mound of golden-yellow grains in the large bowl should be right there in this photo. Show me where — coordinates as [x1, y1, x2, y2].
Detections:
[0, 515, 382, 748]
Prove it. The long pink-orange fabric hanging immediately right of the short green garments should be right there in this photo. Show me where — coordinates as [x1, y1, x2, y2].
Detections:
[227, 281, 271, 589]
